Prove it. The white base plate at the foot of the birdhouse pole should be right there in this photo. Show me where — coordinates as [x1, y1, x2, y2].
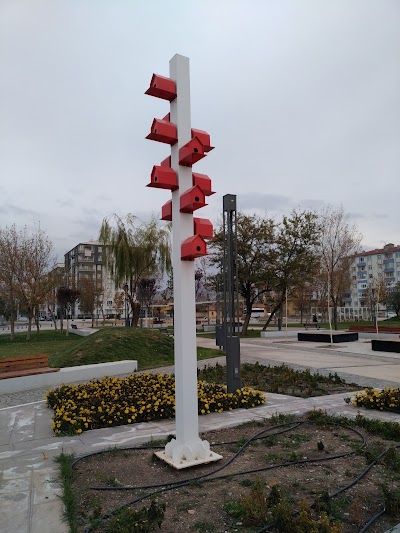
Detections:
[155, 439, 222, 470]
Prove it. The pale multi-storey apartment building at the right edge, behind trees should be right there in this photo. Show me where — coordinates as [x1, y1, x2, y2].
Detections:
[344, 243, 400, 309]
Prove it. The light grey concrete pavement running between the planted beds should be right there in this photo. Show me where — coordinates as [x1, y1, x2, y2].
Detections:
[0, 332, 400, 533]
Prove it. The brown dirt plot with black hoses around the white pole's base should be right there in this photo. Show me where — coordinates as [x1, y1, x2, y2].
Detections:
[70, 419, 400, 533]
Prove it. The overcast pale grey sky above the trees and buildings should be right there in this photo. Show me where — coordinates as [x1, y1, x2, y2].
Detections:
[0, 0, 400, 259]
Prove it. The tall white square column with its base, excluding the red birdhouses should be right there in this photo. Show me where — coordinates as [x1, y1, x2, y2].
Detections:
[157, 54, 221, 468]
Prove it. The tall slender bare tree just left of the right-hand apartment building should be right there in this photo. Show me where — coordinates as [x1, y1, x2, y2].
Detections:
[319, 206, 362, 329]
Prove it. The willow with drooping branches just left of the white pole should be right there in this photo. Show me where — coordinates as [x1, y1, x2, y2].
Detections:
[99, 214, 171, 327]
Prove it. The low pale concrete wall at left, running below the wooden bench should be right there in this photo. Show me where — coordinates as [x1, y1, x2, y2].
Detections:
[0, 359, 137, 394]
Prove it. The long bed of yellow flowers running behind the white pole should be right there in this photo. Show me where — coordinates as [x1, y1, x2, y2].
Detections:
[46, 373, 265, 435]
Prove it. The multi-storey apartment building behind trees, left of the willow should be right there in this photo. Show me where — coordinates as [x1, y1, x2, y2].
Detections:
[64, 241, 118, 318]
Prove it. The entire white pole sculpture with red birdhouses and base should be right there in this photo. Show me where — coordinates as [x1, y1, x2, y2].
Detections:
[146, 54, 221, 468]
